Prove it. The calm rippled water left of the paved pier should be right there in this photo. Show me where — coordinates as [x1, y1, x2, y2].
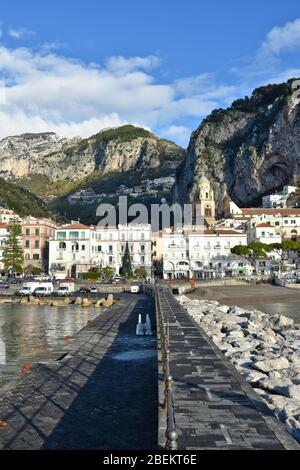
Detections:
[0, 304, 97, 392]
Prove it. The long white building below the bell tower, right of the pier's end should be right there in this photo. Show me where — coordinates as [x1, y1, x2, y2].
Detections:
[163, 230, 247, 279]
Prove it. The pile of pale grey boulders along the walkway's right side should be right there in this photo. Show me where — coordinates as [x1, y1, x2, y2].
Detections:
[178, 296, 300, 442]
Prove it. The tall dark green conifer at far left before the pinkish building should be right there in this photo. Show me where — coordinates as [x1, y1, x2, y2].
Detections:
[3, 219, 24, 274]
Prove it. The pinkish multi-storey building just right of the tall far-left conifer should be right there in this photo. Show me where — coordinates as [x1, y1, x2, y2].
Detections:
[21, 216, 56, 270]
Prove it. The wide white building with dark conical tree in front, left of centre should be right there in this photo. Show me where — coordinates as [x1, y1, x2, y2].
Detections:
[49, 223, 152, 278]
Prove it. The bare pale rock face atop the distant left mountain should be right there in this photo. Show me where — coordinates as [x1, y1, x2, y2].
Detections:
[0, 126, 185, 181]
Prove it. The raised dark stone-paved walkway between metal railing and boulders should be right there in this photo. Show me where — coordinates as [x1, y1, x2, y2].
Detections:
[159, 288, 300, 450]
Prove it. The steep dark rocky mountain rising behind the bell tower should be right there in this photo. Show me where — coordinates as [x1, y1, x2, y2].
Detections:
[173, 80, 300, 216]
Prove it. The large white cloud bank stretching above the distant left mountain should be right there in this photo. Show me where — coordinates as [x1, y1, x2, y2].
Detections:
[0, 46, 233, 143]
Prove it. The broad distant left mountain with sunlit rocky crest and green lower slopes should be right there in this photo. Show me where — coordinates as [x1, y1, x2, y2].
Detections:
[0, 125, 185, 223]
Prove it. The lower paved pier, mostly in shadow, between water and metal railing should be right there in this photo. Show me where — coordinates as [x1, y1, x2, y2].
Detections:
[0, 294, 158, 450]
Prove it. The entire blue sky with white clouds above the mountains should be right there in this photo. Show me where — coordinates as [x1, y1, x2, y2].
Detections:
[0, 0, 300, 147]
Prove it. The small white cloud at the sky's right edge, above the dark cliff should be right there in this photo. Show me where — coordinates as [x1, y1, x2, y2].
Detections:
[260, 18, 300, 55]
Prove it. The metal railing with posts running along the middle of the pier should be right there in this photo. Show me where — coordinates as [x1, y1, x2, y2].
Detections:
[155, 287, 178, 450]
